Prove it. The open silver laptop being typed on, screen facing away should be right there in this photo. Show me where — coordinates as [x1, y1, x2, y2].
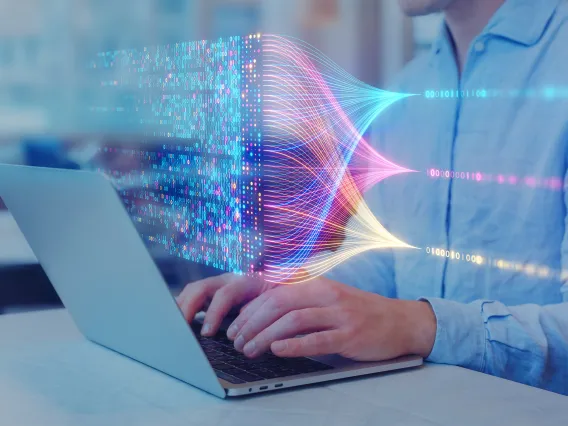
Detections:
[0, 165, 422, 398]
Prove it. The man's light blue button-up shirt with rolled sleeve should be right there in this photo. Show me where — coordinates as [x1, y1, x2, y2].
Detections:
[329, 0, 568, 395]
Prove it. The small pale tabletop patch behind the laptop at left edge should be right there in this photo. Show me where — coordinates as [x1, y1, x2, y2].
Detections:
[0, 210, 37, 267]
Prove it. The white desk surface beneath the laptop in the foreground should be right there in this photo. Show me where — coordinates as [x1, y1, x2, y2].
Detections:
[0, 310, 568, 426]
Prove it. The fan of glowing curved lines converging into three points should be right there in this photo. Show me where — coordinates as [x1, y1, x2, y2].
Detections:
[263, 36, 411, 283]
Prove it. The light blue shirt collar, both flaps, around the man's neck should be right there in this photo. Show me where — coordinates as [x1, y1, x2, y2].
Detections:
[431, 0, 563, 56]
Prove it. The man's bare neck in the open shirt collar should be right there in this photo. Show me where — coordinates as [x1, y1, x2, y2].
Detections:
[444, 0, 505, 74]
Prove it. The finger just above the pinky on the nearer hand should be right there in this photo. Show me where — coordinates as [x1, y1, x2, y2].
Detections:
[243, 308, 336, 358]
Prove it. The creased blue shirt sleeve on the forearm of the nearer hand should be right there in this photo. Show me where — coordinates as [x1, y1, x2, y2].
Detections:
[422, 162, 568, 395]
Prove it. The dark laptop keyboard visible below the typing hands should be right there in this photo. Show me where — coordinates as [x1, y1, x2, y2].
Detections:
[191, 323, 333, 384]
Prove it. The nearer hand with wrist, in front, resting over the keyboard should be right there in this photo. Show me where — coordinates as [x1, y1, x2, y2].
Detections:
[227, 277, 436, 361]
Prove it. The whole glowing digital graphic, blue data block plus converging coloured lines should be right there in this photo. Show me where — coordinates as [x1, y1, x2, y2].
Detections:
[90, 34, 413, 282]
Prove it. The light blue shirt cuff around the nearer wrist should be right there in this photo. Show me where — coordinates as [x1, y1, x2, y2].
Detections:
[420, 297, 486, 371]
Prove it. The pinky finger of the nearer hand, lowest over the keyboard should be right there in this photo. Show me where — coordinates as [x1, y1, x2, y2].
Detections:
[270, 330, 344, 358]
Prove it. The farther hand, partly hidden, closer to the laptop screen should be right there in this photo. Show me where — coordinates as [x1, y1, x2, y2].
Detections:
[177, 274, 275, 336]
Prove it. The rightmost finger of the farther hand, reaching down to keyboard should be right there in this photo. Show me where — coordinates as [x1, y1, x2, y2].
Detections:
[201, 275, 264, 336]
